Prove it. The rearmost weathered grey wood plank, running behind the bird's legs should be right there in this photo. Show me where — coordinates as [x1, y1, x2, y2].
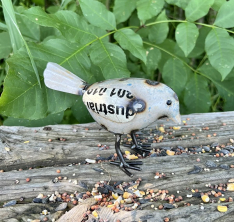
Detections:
[0, 112, 234, 171]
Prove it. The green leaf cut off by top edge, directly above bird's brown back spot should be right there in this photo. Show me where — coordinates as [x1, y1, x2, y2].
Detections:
[137, 0, 164, 23]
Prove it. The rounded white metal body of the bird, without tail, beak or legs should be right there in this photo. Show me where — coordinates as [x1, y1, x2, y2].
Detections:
[83, 78, 178, 134]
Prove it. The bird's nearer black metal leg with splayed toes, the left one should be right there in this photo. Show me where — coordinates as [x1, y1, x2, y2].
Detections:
[110, 134, 142, 177]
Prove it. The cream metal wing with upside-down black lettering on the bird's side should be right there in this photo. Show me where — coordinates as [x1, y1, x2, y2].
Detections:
[83, 87, 145, 123]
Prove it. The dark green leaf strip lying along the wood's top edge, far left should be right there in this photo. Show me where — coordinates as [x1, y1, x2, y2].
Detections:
[3, 112, 64, 127]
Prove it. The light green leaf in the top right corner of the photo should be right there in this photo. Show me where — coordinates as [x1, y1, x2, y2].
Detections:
[214, 0, 234, 28]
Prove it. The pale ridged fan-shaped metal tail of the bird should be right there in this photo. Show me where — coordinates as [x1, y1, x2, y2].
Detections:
[44, 62, 87, 95]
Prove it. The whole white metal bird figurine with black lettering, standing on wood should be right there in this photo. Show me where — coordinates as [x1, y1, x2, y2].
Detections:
[44, 62, 181, 177]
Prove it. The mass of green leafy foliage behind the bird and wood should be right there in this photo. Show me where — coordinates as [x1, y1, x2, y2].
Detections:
[0, 0, 234, 126]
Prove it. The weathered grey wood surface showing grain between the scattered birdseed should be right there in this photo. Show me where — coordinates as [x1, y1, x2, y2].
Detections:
[0, 112, 234, 222]
